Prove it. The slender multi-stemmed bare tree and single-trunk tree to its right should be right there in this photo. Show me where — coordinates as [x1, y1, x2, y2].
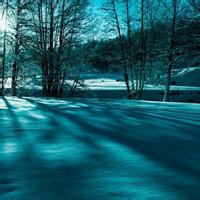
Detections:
[99, 0, 199, 101]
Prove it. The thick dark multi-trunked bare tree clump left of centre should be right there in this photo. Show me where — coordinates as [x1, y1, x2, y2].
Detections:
[27, 0, 87, 97]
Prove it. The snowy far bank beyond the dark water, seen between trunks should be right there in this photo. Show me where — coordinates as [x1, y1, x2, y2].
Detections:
[1, 67, 200, 90]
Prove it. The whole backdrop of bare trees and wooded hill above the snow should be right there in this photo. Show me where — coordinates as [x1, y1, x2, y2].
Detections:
[0, 0, 200, 102]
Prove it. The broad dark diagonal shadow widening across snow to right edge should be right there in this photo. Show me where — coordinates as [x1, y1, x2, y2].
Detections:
[21, 97, 200, 198]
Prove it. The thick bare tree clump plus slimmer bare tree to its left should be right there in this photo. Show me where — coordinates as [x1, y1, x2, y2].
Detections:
[2, 0, 88, 97]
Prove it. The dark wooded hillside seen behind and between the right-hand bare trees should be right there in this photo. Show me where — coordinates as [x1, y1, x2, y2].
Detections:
[82, 19, 200, 78]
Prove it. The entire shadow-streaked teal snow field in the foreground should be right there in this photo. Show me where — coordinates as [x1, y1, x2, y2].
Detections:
[0, 98, 200, 200]
